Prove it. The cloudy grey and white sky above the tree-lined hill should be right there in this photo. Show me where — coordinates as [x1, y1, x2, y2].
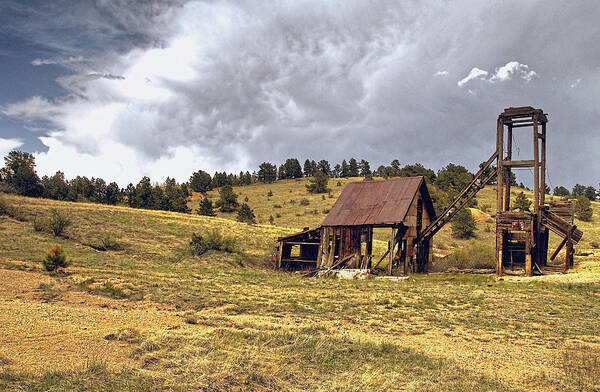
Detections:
[0, 0, 600, 188]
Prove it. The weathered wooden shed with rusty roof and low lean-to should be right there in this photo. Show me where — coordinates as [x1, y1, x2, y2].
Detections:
[278, 177, 435, 274]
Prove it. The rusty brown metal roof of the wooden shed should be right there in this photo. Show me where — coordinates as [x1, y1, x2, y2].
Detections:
[322, 176, 435, 226]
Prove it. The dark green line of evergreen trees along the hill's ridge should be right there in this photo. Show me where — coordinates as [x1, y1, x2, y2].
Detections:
[0, 151, 598, 217]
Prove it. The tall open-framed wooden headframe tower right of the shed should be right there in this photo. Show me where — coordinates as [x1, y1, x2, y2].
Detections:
[496, 106, 583, 275]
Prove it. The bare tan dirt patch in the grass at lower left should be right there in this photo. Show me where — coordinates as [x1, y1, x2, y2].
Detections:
[0, 270, 191, 374]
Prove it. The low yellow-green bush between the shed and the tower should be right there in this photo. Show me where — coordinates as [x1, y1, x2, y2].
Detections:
[430, 244, 496, 272]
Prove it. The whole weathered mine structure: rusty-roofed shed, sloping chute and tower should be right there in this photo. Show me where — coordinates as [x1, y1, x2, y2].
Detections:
[278, 106, 583, 275]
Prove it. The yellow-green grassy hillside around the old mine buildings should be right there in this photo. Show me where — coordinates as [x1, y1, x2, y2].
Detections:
[0, 188, 600, 391]
